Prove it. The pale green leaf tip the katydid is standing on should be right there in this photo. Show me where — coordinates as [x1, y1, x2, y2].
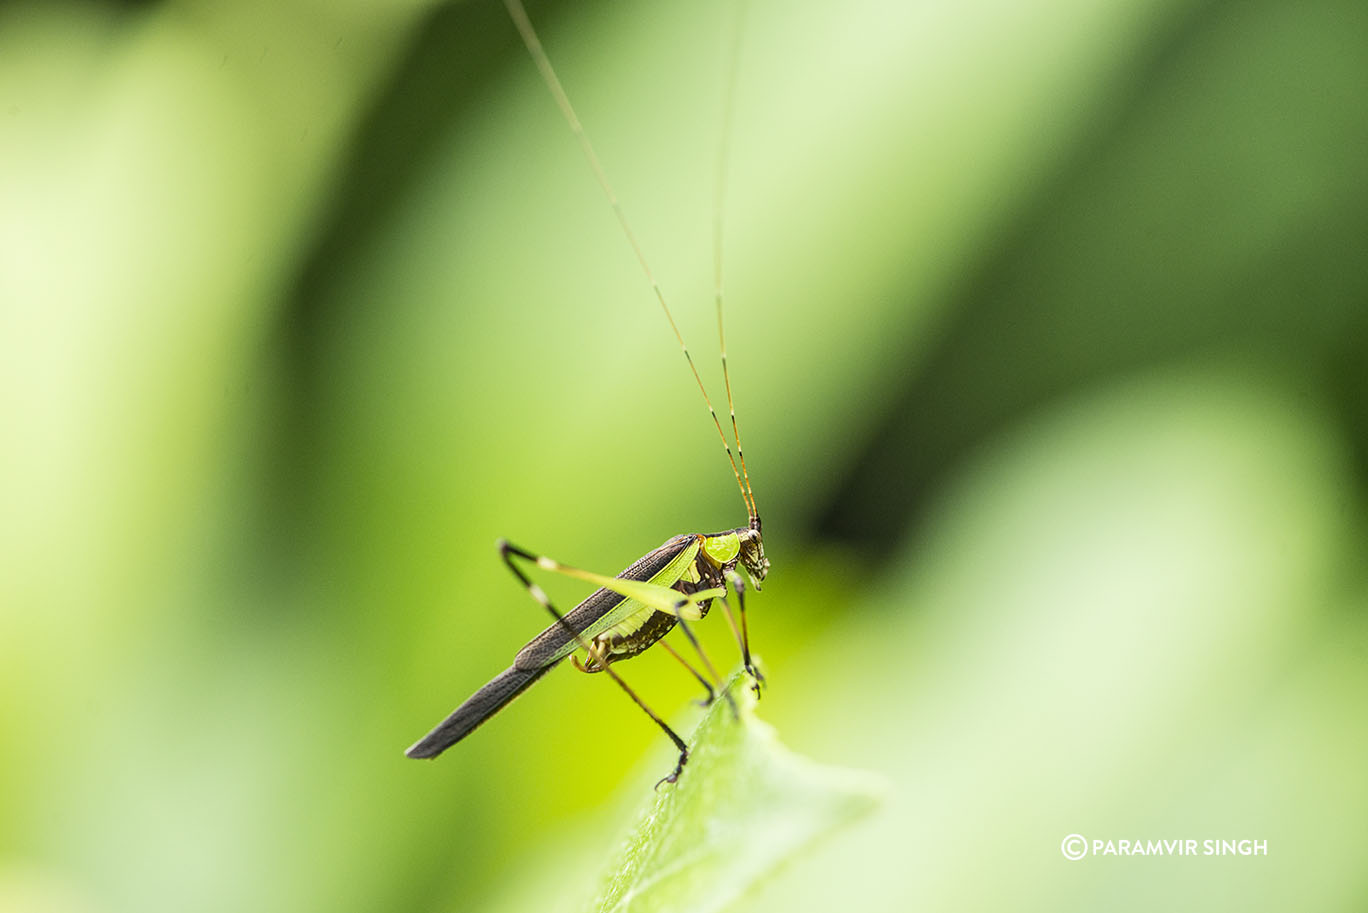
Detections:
[590, 673, 884, 913]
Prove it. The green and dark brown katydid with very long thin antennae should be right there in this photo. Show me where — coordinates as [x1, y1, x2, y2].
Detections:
[406, 0, 770, 783]
